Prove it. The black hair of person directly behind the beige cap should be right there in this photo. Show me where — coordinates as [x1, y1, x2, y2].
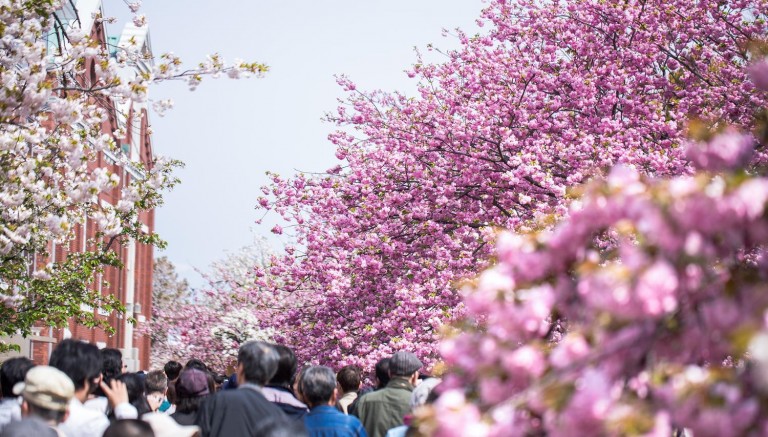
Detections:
[48, 339, 101, 391]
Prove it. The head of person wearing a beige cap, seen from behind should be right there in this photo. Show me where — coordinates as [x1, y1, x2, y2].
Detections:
[13, 366, 75, 424]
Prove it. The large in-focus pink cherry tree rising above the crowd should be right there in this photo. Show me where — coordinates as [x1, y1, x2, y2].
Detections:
[253, 0, 768, 368]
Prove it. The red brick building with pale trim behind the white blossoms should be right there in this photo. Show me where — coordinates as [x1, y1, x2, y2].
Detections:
[0, 0, 154, 371]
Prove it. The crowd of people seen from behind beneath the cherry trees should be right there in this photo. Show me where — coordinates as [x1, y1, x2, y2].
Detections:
[0, 340, 440, 437]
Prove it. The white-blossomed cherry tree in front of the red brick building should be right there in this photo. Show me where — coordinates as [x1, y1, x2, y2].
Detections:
[0, 0, 266, 351]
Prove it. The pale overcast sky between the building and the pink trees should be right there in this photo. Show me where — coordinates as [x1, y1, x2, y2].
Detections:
[104, 0, 483, 287]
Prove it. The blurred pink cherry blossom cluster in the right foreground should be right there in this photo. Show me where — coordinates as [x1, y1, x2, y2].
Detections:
[422, 60, 768, 437]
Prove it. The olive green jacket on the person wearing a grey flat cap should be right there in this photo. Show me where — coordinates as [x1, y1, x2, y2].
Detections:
[356, 377, 413, 437]
